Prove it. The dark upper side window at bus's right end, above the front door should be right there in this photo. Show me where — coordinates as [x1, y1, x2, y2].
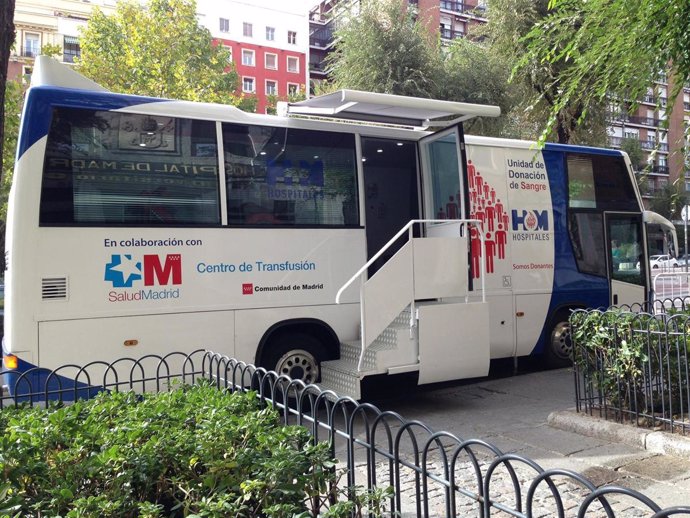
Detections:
[567, 153, 639, 211]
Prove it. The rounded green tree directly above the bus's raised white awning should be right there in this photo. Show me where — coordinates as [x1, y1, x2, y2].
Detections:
[327, 0, 441, 97]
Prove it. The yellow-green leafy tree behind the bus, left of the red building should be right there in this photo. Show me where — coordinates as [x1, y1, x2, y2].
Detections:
[78, 0, 242, 105]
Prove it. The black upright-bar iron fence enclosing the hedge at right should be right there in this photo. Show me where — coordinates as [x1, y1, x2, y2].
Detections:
[571, 304, 690, 434]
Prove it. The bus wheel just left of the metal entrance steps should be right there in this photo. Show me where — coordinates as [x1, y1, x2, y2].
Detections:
[262, 333, 326, 385]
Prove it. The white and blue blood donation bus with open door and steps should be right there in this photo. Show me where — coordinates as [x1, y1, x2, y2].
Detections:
[3, 57, 677, 397]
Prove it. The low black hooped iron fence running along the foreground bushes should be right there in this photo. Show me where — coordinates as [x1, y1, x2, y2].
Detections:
[0, 350, 690, 518]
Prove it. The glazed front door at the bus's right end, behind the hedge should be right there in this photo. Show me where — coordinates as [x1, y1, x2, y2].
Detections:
[604, 212, 649, 306]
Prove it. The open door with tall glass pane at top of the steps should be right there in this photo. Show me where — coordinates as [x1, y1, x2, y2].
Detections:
[420, 126, 467, 241]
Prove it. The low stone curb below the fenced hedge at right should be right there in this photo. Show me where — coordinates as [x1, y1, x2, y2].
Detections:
[546, 410, 690, 460]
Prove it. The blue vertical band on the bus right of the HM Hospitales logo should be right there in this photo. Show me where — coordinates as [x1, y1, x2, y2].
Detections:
[532, 148, 608, 354]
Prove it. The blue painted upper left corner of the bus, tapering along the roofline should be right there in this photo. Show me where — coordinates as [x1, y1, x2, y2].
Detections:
[17, 86, 168, 160]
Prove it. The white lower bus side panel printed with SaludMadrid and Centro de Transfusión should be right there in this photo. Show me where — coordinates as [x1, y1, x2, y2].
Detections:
[22, 228, 365, 367]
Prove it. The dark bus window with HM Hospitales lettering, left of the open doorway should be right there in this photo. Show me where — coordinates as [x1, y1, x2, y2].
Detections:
[223, 123, 359, 226]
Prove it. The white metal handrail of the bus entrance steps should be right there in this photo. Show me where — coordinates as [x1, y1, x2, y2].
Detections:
[335, 219, 486, 372]
